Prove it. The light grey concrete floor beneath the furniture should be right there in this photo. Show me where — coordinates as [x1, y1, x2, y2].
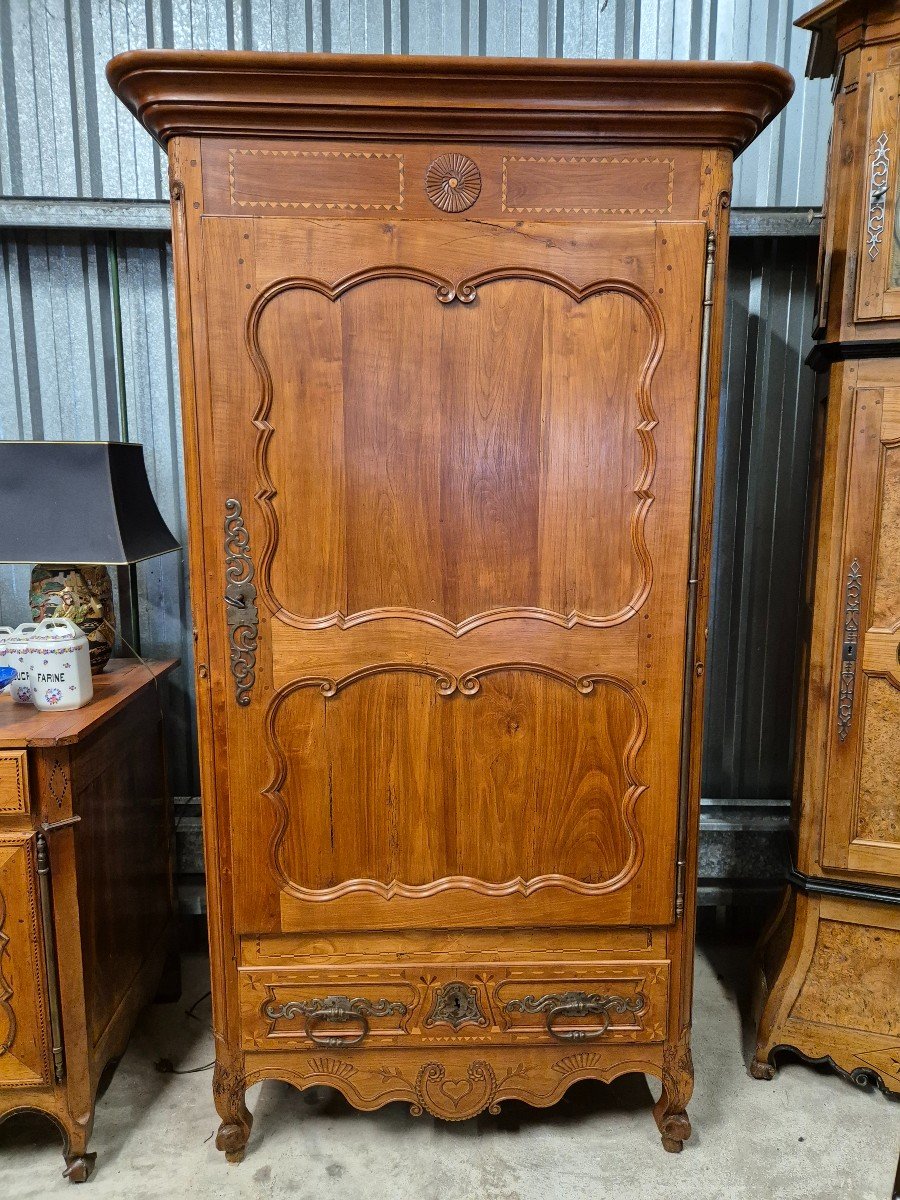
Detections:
[0, 943, 900, 1200]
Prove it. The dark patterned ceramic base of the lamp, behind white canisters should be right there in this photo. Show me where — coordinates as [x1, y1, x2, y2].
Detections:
[29, 564, 115, 674]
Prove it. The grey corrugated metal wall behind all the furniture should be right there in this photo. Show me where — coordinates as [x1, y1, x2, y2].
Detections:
[0, 0, 830, 902]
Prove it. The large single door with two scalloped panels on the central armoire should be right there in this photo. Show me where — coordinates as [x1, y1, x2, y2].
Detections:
[196, 148, 706, 931]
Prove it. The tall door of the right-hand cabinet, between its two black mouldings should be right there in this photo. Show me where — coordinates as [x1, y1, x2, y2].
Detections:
[823, 376, 900, 880]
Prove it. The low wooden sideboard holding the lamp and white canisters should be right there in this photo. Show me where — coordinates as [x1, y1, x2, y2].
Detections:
[0, 659, 178, 1183]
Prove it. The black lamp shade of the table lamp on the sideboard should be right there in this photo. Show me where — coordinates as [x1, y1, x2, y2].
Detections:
[0, 442, 180, 565]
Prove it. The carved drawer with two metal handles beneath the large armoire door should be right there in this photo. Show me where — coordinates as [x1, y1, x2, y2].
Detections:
[240, 961, 670, 1050]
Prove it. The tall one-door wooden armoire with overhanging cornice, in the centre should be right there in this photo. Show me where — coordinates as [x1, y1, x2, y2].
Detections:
[109, 52, 792, 1159]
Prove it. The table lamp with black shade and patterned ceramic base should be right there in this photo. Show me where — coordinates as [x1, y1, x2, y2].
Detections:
[0, 442, 180, 674]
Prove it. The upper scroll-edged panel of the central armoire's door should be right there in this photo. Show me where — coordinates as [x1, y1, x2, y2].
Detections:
[254, 274, 661, 632]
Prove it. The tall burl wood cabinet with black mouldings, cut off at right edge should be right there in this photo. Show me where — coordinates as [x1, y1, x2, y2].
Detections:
[751, 0, 900, 1092]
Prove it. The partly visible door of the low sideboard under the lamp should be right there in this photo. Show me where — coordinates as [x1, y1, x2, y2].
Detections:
[0, 834, 50, 1087]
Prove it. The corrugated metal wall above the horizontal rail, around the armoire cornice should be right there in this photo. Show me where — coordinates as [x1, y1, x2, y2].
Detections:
[0, 0, 830, 205]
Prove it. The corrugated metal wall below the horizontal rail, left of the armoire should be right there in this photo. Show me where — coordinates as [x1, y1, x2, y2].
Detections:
[0, 230, 197, 793]
